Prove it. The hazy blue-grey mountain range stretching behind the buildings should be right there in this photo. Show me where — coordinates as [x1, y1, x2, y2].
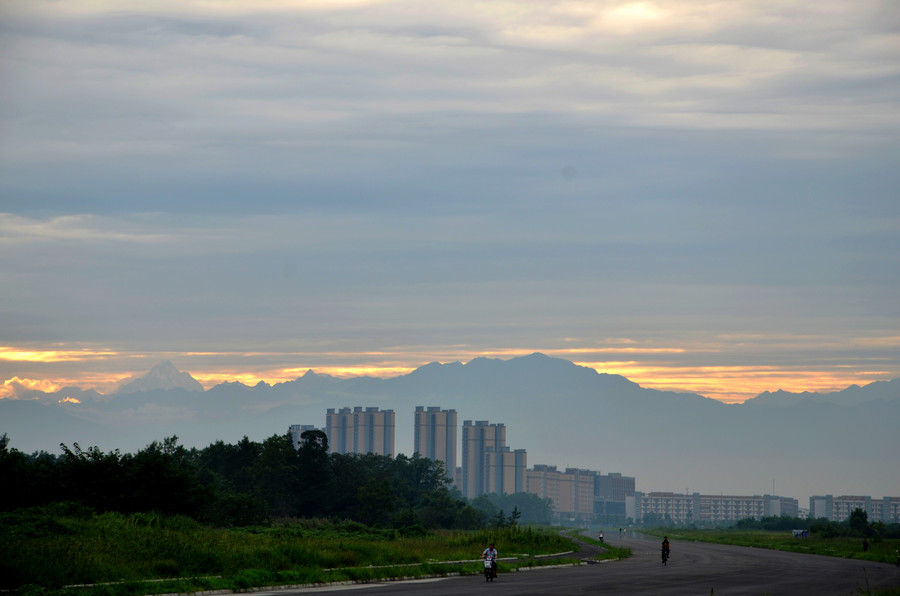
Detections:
[0, 353, 900, 506]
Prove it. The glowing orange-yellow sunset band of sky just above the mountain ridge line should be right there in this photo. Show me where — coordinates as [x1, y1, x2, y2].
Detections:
[0, 336, 900, 403]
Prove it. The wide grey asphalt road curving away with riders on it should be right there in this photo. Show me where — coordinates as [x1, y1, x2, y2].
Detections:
[253, 538, 900, 596]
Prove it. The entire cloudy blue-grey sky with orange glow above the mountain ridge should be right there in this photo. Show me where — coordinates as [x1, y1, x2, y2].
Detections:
[0, 0, 900, 402]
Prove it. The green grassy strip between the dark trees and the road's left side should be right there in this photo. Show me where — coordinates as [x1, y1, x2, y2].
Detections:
[0, 509, 573, 596]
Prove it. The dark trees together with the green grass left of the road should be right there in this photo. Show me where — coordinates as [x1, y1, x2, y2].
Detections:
[0, 431, 573, 596]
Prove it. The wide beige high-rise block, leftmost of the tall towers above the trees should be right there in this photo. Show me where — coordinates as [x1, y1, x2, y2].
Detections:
[325, 406, 395, 456]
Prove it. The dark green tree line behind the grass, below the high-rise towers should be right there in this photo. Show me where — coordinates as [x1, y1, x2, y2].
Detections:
[0, 430, 550, 532]
